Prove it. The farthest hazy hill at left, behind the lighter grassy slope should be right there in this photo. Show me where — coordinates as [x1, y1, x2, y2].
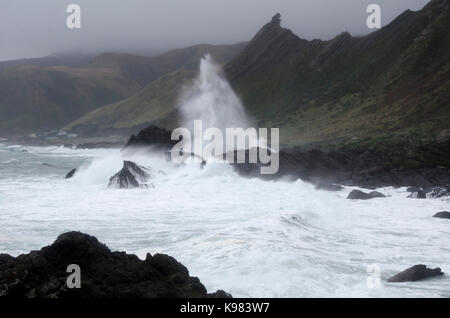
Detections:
[0, 43, 246, 135]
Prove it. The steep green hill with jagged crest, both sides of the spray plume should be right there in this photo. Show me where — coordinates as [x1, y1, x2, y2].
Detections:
[68, 0, 450, 146]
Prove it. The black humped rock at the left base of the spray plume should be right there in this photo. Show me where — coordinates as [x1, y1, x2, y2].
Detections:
[123, 125, 178, 150]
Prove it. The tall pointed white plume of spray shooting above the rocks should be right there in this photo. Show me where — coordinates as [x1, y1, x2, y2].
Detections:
[178, 54, 257, 159]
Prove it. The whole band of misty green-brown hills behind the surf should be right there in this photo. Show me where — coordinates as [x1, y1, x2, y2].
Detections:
[0, 0, 450, 154]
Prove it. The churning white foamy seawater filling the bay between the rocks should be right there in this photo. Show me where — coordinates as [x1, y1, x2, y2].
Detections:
[0, 144, 450, 297]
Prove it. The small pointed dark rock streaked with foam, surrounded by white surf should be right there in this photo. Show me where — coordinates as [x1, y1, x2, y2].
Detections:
[108, 160, 152, 189]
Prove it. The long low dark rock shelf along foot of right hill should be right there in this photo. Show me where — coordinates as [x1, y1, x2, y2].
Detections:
[225, 144, 450, 190]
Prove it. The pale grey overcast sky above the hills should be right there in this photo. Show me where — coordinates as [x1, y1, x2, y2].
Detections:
[0, 0, 428, 61]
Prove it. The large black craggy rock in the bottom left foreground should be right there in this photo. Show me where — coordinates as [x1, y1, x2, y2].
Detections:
[0, 232, 231, 298]
